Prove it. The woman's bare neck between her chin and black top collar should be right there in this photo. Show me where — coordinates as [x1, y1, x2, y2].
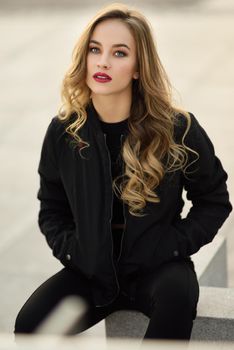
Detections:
[92, 95, 132, 123]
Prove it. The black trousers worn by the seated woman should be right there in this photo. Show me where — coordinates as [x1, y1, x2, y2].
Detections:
[14, 260, 199, 340]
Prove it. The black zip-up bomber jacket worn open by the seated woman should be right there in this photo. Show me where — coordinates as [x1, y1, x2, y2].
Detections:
[38, 101, 232, 306]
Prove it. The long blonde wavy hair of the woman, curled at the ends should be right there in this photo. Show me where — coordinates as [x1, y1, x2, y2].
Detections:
[59, 3, 197, 216]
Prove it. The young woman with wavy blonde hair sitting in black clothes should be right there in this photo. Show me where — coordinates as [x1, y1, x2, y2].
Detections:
[15, 4, 232, 339]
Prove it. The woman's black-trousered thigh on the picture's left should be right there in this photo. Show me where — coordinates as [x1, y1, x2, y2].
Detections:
[15, 268, 91, 333]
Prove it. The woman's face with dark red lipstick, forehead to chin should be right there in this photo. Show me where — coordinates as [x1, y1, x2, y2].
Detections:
[86, 19, 138, 96]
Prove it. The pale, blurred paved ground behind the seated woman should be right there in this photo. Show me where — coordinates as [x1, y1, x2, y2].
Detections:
[0, 0, 234, 332]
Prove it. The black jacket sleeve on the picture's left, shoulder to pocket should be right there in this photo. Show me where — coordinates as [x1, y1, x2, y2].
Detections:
[37, 117, 77, 267]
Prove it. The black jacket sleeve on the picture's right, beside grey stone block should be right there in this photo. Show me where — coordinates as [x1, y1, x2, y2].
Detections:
[171, 114, 232, 256]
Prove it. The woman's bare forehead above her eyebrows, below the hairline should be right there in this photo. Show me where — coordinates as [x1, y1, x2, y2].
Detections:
[90, 19, 135, 47]
